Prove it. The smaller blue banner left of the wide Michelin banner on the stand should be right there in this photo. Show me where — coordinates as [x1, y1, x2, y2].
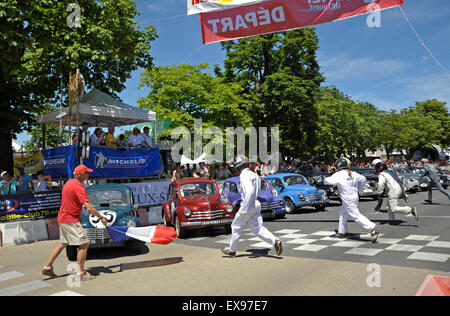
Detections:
[42, 145, 76, 177]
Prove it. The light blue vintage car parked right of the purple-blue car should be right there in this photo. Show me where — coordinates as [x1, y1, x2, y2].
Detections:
[263, 173, 329, 214]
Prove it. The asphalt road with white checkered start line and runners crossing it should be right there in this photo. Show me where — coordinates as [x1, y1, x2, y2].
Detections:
[0, 192, 450, 298]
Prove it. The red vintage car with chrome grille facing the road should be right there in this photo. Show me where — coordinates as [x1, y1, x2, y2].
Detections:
[162, 178, 236, 238]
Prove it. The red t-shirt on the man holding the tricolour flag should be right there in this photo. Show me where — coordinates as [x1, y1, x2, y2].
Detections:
[58, 179, 89, 223]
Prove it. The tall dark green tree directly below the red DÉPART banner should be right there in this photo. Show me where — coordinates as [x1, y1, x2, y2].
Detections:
[216, 28, 324, 158]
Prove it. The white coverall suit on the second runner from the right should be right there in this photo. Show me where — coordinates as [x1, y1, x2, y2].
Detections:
[377, 171, 413, 221]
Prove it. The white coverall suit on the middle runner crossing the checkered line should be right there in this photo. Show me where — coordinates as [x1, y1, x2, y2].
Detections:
[324, 170, 376, 234]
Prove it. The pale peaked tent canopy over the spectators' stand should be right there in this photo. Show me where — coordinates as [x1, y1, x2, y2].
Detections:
[37, 89, 156, 127]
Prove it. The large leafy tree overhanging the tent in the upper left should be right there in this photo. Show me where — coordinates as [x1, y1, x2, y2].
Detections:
[0, 0, 157, 170]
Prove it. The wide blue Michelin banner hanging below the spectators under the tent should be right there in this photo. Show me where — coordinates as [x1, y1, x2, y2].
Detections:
[83, 147, 162, 178]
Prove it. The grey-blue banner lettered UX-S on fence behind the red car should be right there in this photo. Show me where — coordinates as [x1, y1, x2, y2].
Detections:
[123, 181, 170, 207]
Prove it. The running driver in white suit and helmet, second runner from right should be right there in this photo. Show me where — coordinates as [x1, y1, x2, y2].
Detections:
[372, 159, 419, 224]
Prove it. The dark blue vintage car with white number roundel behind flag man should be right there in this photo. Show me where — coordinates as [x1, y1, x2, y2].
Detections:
[66, 183, 145, 261]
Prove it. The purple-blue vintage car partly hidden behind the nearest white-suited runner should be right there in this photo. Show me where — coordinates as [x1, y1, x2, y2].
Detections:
[221, 177, 286, 219]
